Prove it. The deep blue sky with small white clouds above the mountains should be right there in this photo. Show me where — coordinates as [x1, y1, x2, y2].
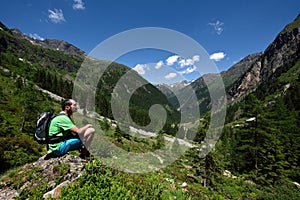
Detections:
[0, 0, 300, 83]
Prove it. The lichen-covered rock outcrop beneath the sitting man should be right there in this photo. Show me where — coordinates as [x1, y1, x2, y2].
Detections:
[0, 154, 86, 200]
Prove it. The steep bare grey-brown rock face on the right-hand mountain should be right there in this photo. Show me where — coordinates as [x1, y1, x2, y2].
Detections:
[228, 19, 300, 101]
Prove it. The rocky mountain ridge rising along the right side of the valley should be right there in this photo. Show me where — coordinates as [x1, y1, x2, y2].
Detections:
[168, 15, 300, 113]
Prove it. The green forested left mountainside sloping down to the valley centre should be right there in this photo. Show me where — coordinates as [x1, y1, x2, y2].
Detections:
[0, 20, 180, 131]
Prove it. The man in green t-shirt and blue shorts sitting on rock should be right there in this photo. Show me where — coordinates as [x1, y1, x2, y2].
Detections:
[46, 99, 95, 159]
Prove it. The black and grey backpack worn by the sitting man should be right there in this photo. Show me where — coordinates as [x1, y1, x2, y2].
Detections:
[34, 112, 64, 144]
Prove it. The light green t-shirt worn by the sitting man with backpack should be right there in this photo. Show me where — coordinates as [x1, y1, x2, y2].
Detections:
[48, 112, 75, 153]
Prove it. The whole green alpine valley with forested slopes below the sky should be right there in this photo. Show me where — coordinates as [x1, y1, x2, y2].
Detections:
[0, 15, 300, 199]
